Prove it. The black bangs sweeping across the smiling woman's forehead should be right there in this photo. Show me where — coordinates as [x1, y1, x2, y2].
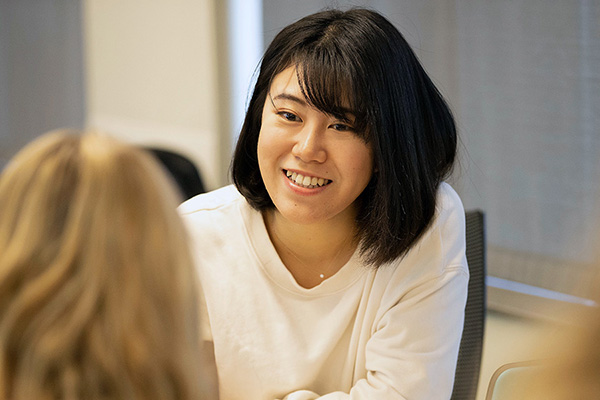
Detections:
[292, 48, 371, 142]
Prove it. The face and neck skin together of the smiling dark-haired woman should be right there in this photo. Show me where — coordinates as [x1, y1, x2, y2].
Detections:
[257, 67, 373, 288]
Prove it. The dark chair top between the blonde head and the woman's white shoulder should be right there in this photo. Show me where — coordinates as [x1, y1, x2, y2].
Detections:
[146, 147, 206, 200]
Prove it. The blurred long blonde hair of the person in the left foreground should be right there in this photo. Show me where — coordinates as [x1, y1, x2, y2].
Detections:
[0, 131, 211, 400]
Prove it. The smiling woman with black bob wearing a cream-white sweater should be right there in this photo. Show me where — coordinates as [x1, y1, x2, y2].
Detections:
[180, 9, 468, 400]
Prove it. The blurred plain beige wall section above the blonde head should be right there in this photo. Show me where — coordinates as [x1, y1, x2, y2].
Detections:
[83, 0, 228, 188]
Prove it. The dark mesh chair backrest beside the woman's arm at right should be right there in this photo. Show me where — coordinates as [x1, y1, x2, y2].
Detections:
[451, 210, 486, 400]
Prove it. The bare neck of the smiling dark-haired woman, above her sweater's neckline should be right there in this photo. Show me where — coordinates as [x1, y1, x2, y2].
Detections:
[263, 210, 357, 288]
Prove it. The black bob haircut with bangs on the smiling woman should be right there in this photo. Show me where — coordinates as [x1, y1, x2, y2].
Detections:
[232, 8, 457, 267]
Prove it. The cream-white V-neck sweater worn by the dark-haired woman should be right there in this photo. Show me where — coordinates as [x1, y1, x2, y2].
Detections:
[180, 183, 468, 400]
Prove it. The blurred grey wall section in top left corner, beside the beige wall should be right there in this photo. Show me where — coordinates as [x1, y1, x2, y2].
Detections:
[0, 0, 85, 168]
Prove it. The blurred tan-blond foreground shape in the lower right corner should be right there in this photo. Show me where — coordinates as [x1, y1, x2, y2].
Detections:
[486, 237, 600, 400]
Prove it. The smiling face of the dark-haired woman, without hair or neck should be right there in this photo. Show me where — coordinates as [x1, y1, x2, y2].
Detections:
[257, 67, 373, 224]
